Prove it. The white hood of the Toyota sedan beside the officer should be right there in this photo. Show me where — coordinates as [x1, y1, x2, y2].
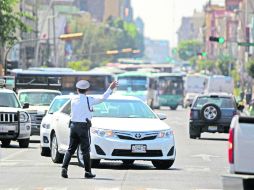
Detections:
[92, 117, 170, 132]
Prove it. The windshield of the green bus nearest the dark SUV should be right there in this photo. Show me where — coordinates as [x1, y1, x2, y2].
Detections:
[159, 76, 183, 95]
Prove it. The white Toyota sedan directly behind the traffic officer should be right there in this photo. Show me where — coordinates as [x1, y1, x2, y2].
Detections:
[50, 95, 176, 169]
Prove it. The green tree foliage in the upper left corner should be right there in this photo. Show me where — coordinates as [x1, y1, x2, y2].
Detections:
[0, 0, 29, 47]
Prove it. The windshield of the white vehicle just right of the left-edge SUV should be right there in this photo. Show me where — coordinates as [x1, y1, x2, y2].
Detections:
[19, 92, 60, 106]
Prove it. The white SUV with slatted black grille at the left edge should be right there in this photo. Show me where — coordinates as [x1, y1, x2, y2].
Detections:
[0, 89, 31, 148]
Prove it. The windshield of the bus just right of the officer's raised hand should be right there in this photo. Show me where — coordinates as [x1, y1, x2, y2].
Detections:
[118, 76, 147, 91]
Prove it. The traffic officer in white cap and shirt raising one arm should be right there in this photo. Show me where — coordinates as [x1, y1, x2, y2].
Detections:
[61, 80, 118, 178]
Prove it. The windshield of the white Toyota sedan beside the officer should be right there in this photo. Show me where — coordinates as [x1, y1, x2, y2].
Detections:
[93, 100, 156, 118]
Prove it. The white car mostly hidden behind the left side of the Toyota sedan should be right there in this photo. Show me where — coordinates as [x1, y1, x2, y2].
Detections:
[40, 95, 71, 156]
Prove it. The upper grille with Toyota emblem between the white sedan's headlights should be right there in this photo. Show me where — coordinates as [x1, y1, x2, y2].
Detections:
[115, 132, 159, 141]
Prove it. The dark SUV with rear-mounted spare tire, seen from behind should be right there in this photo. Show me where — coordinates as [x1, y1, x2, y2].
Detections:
[189, 93, 243, 139]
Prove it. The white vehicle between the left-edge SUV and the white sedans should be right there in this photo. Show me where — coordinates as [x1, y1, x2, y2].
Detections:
[18, 89, 61, 135]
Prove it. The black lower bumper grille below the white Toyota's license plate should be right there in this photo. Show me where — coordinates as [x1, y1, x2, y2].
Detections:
[112, 149, 162, 157]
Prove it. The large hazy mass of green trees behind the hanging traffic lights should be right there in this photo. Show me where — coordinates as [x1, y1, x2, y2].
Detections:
[68, 17, 144, 69]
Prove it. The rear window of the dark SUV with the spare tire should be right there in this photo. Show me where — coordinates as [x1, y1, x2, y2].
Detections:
[194, 96, 235, 108]
